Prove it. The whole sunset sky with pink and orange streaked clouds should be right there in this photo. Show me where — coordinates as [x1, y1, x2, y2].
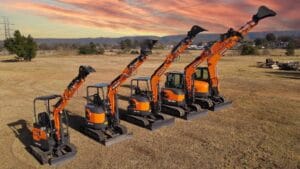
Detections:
[0, 0, 300, 39]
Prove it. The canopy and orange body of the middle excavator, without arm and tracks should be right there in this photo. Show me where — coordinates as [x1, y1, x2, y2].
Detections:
[127, 77, 152, 115]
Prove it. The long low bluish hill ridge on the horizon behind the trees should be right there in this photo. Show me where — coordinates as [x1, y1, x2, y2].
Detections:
[29, 31, 300, 45]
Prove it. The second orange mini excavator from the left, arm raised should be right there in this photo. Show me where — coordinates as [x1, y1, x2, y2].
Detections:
[84, 40, 156, 145]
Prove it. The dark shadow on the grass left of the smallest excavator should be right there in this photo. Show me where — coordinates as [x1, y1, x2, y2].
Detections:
[7, 119, 32, 152]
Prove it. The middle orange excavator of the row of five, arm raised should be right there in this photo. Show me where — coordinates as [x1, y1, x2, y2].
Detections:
[121, 26, 205, 130]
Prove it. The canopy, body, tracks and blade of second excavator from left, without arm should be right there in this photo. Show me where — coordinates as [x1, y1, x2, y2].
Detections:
[83, 83, 131, 146]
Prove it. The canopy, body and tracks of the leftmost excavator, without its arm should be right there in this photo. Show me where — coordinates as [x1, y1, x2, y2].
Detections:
[30, 95, 76, 164]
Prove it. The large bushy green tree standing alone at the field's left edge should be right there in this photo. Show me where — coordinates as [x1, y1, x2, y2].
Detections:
[4, 30, 37, 61]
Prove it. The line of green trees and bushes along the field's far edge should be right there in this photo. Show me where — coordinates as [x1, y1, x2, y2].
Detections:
[0, 31, 300, 61]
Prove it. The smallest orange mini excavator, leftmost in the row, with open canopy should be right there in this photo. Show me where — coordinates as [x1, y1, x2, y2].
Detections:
[29, 66, 95, 165]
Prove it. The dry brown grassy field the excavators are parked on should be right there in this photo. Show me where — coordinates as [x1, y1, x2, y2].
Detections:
[0, 51, 300, 169]
